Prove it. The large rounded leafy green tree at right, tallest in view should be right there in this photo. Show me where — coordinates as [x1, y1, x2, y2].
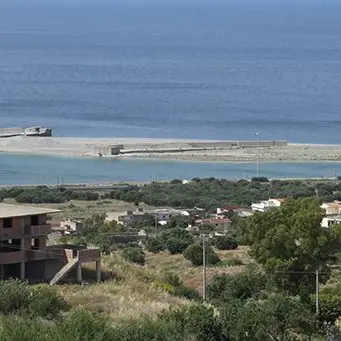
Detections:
[244, 198, 340, 295]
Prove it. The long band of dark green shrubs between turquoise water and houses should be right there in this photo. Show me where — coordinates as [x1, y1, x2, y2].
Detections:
[0, 178, 341, 209]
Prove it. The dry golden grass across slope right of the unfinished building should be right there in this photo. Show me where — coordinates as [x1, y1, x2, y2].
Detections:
[58, 247, 250, 323]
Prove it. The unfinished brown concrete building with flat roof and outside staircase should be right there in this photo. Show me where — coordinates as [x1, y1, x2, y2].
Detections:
[0, 203, 101, 284]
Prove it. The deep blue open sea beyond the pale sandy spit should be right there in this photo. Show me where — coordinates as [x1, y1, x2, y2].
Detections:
[0, 0, 341, 182]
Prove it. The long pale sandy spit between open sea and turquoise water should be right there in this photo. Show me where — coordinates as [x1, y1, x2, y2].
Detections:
[0, 136, 341, 162]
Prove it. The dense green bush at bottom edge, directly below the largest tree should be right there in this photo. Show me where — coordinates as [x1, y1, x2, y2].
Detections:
[220, 294, 314, 341]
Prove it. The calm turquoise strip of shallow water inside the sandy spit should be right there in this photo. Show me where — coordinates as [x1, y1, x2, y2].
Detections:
[0, 154, 341, 185]
